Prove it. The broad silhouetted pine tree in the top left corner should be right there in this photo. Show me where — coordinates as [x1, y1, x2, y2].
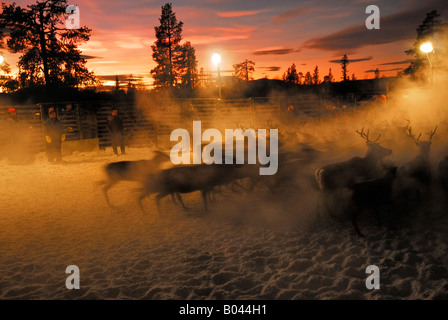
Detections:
[0, 0, 96, 88]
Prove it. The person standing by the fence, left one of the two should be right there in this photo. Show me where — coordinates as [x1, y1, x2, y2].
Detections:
[44, 108, 65, 162]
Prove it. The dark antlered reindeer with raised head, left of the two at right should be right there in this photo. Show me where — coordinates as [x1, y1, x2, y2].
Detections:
[314, 128, 392, 215]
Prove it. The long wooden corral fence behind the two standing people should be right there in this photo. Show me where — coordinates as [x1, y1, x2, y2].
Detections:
[0, 98, 330, 156]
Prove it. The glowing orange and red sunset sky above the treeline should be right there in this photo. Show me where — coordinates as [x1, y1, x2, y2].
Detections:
[4, 0, 448, 87]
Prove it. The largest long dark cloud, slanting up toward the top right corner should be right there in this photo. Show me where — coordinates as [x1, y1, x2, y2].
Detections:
[304, 2, 448, 51]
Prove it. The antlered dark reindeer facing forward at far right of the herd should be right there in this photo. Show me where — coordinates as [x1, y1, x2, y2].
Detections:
[397, 126, 437, 212]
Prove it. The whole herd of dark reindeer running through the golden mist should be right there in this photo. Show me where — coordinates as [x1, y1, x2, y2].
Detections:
[103, 126, 448, 237]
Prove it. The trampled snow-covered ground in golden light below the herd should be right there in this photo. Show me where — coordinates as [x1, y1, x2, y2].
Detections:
[0, 148, 448, 300]
